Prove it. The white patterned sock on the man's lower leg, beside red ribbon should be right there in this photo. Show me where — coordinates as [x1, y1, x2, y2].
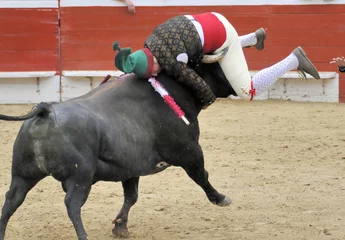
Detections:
[252, 53, 299, 95]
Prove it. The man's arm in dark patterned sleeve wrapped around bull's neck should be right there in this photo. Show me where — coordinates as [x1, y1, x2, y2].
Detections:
[167, 61, 216, 106]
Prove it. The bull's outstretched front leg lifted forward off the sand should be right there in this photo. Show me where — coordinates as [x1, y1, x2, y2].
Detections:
[180, 144, 232, 206]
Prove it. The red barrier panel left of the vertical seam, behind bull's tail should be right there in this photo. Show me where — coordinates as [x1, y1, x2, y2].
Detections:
[0, 8, 59, 72]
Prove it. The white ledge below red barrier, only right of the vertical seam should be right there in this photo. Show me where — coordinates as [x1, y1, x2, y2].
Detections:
[61, 71, 339, 102]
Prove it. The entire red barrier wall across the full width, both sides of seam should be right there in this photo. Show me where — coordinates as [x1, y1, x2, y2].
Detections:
[0, 4, 345, 101]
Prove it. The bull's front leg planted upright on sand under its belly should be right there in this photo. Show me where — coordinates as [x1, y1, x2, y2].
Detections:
[113, 177, 139, 238]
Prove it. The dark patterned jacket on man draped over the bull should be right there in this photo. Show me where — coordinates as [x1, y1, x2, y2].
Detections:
[145, 16, 216, 105]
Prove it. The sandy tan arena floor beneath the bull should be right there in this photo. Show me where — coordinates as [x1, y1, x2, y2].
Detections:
[0, 100, 345, 240]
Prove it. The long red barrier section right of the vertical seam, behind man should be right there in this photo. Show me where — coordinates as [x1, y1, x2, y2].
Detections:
[61, 5, 345, 71]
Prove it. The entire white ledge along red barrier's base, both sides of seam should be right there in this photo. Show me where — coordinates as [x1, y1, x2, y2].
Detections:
[0, 71, 339, 104]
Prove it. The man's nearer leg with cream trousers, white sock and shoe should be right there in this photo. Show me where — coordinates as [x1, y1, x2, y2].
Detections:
[214, 13, 320, 100]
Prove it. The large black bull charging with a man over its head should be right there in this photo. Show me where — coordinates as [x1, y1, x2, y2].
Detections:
[0, 63, 233, 239]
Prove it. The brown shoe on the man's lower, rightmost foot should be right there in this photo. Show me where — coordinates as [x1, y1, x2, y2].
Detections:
[292, 47, 320, 79]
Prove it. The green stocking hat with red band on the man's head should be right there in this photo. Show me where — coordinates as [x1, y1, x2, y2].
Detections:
[113, 42, 153, 78]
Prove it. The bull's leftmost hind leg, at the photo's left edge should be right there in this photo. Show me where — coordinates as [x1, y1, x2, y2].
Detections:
[0, 176, 42, 239]
